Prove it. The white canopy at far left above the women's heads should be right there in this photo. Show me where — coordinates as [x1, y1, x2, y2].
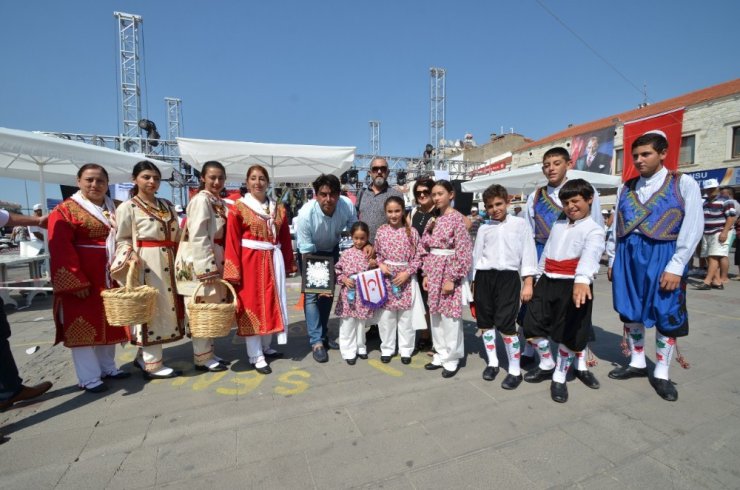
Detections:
[0, 128, 172, 208]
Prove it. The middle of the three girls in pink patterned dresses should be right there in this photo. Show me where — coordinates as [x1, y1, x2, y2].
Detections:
[374, 196, 426, 364]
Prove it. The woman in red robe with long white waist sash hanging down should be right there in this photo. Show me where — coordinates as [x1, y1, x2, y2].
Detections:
[224, 165, 296, 374]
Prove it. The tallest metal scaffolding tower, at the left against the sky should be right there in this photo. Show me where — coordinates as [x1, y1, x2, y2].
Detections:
[113, 12, 144, 152]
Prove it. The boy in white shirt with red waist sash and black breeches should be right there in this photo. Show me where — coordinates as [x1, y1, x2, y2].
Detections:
[524, 179, 606, 403]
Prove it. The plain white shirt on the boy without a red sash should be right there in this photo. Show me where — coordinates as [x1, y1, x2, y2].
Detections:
[471, 216, 537, 280]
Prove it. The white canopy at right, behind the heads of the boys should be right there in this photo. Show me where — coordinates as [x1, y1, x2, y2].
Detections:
[462, 165, 622, 194]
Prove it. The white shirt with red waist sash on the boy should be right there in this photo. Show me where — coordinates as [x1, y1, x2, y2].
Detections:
[538, 216, 606, 284]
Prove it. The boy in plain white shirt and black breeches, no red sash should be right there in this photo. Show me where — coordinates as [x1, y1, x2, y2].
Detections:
[473, 184, 537, 390]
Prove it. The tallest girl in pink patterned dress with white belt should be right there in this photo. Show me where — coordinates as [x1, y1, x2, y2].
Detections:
[421, 180, 473, 378]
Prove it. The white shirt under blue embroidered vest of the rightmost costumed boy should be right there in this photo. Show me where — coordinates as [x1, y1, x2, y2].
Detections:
[606, 167, 704, 276]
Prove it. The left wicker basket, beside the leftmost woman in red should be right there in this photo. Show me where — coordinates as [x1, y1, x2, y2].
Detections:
[100, 265, 158, 326]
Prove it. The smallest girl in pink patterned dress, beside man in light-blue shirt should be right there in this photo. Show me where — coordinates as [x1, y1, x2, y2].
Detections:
[334, 221, 373, 366]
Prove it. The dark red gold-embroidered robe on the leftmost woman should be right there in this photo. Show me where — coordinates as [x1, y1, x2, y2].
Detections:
[49, 199, 129, 347]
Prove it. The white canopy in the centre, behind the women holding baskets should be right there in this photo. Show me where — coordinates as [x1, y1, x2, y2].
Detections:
[177, 138, 356, 182]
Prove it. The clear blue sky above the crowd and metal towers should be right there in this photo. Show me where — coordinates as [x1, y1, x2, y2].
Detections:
[0, 0, 740, 209]
